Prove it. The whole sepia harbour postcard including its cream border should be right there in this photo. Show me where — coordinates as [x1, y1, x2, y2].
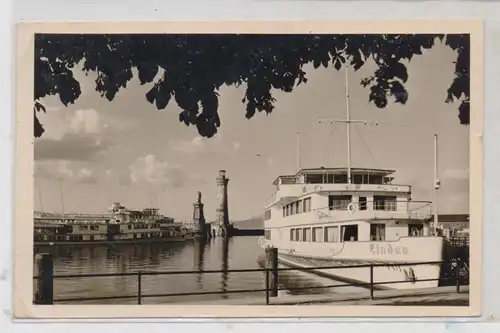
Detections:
[16, 22, 482, 315]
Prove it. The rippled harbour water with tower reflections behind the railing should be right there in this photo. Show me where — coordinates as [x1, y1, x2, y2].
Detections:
[35, 236, 360, 304]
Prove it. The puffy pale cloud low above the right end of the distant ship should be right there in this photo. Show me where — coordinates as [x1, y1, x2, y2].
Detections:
[130, 154, 189, 187]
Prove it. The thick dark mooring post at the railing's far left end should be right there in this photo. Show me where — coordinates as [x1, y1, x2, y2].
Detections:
[34, 253, 54, 304]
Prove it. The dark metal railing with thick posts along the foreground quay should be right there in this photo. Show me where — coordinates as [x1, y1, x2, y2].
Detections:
[33, 247, 469, 305]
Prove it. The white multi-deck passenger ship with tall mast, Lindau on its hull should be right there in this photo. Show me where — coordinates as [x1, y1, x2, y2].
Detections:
[259, 65, 444, 289]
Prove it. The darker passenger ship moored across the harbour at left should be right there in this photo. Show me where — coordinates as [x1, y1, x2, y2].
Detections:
[34, 203, 192, 246]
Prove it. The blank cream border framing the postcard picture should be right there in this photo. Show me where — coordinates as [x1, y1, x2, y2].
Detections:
[13, 19, 483, 319]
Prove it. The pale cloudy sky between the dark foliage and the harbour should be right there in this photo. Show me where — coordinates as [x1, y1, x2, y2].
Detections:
[34, 38, 469, 221]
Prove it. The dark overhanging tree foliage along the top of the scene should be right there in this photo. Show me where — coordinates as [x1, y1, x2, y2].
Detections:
[34, 34, 470, 137]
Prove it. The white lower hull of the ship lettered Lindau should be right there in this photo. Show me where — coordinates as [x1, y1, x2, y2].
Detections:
[260, 237, 443, 289]
